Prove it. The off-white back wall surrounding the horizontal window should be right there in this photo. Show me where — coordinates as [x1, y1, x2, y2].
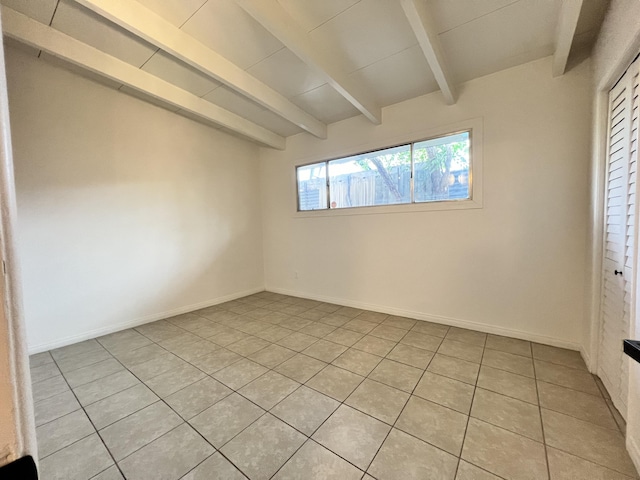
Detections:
[260, 58, 591, 349]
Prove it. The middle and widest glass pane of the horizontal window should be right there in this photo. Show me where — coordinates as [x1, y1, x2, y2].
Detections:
[329, 145, 411, 208]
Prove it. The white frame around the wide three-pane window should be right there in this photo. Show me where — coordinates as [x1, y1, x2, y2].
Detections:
[292, 118, 483, 218]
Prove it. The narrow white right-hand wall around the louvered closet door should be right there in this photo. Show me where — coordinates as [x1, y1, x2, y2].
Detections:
[584, 0, 640, 470]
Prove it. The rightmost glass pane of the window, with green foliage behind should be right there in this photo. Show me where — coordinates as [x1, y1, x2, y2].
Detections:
[413, 132, 471, 202]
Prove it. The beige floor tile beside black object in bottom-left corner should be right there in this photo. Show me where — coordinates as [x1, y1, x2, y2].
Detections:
[39, 433, 113, 480]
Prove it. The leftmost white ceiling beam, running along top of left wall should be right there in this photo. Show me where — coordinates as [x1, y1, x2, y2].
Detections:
[2, 7, 285, 150]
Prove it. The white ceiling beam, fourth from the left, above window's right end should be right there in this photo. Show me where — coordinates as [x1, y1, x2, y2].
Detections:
[401, 0, 456, 105]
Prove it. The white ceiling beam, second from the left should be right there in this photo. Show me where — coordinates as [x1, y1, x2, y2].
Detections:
[76, 0, 327, 138]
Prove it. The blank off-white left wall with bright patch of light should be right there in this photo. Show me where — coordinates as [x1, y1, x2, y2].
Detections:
[8, 48, 263, 352]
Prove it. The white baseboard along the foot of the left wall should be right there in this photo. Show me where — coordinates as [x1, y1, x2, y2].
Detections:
[29, 287, 264, 355]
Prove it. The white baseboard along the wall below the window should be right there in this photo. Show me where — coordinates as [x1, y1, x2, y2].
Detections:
[266, 286, 581, 351]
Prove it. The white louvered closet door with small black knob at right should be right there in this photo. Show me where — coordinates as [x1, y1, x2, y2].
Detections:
[598, 54, 640, 418]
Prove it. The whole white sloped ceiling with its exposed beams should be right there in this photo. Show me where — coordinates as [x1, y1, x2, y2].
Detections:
[0, 0, 608, 148]
